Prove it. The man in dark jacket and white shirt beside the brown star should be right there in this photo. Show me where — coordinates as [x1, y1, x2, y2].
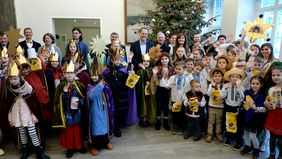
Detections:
[19, 28, 41, 58]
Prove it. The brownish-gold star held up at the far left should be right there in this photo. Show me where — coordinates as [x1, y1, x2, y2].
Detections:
[5, 27, 23, 57]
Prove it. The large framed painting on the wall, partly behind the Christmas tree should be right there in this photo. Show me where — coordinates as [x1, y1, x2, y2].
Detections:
[125, 0, 155, 44]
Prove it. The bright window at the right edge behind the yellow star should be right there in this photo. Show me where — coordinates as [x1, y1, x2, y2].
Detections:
[257, 0, 282, 58]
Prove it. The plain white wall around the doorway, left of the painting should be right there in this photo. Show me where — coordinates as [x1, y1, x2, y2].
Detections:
[15, 0, 125, 43]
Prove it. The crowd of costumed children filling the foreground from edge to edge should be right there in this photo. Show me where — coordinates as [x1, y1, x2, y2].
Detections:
[0, 28, 282, 159]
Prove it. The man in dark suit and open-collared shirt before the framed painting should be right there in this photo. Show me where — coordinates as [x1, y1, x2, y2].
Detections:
[130, 27, 154, 72]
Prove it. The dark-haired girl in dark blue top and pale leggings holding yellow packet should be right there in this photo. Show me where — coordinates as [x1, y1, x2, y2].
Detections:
[241, 76, 266, 158]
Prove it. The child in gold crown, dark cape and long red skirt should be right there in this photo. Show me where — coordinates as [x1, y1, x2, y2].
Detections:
[53, 61, 87, 158]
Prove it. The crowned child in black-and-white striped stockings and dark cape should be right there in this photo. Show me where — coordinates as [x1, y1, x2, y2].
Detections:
[8, 63, 50, 159]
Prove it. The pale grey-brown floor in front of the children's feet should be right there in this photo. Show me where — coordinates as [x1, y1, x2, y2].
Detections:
[0, 126, 250, 159]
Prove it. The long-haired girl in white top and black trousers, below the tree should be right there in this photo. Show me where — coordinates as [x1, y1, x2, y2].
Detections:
[151, 52, 175, 131]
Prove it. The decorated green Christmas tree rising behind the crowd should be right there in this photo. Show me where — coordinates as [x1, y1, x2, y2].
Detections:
[147, 0, 216, 45]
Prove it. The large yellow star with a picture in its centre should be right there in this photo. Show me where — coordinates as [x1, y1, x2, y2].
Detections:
[244, 18, 272, 43]
